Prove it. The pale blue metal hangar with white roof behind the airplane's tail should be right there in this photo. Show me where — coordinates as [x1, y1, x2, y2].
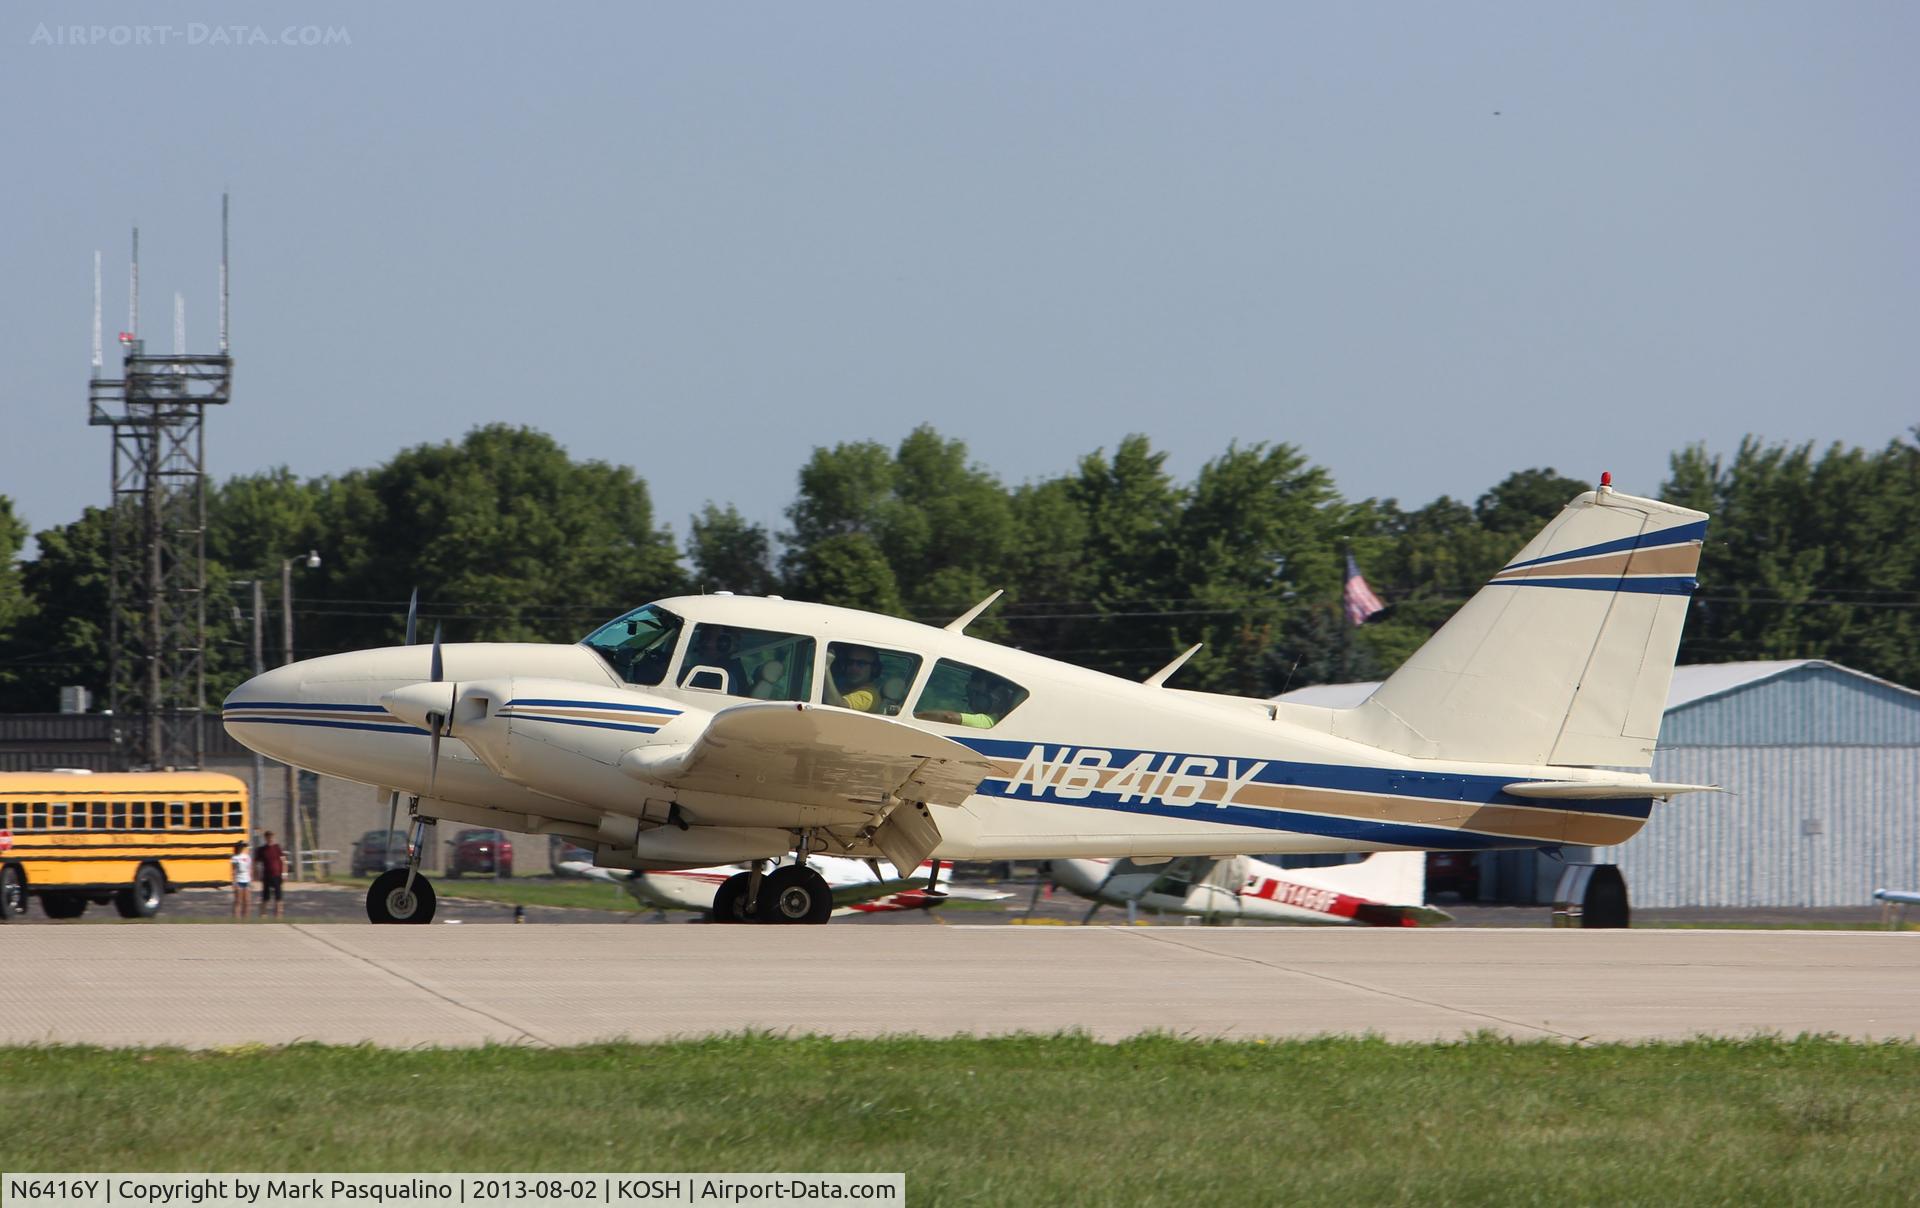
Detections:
[1283, 659, 1920, 906]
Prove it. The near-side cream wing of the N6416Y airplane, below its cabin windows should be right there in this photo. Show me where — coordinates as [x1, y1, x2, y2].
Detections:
[620, 701, 993, 810]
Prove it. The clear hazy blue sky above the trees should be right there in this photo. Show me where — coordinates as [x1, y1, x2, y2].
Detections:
[0, 2, 1920, 549]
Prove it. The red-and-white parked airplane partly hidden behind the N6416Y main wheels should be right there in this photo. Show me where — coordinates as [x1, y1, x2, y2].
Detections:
[561, 857, 1012, 922]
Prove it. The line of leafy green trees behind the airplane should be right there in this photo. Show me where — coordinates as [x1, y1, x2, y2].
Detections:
[0, 424, 1920, 713]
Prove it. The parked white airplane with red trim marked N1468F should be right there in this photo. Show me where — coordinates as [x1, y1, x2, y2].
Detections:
[1052, 851, 1453, 928]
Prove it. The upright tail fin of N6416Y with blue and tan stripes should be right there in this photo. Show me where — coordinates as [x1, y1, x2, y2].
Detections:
[1334, 486, 1707, 768]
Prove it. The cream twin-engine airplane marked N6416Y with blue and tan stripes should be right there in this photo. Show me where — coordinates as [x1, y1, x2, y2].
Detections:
[225, 478, 1707, 922]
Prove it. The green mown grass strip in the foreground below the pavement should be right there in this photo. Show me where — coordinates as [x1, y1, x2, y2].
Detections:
[0, 1035, 1920, 1204]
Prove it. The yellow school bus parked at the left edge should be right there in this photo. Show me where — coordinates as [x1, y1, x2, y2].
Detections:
[0, 772, 252, 922]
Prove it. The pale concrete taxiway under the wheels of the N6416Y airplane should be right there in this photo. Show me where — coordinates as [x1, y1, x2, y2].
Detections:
[0, 924, 1920, 1047]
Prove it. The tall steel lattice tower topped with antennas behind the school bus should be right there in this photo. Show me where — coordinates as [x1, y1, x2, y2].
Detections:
[86, 194, 232, 768]
